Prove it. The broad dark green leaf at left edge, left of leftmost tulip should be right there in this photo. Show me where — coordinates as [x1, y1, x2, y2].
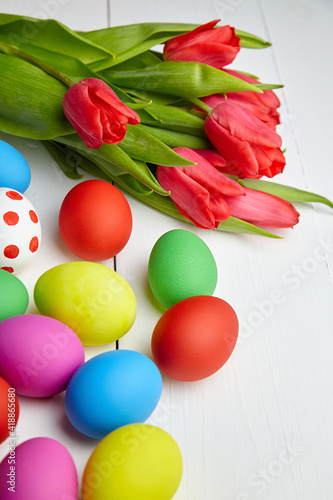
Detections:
[0, 54, 73, 139]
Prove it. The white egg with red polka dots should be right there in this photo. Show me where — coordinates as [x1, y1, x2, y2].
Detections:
[0, 188, 41, 273]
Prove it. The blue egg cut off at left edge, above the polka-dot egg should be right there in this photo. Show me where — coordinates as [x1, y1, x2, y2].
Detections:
[0, 140, 31, 193]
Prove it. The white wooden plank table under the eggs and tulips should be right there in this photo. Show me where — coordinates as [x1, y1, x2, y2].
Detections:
[0, 0, 333, 500]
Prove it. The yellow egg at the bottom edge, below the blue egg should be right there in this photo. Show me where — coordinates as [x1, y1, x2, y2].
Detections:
[82, 424, 183, 500]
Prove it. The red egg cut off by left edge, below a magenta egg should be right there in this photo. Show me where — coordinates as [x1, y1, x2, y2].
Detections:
[0, 377, 20, 444]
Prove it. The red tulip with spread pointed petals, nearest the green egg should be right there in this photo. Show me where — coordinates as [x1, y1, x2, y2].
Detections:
[156, 148, 245, 229]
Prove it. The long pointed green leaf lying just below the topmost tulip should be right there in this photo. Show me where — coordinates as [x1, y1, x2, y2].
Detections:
[101, 61, 261, 99]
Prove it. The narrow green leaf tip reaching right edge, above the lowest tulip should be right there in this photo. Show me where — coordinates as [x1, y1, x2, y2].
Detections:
[237, 179, 333, 208]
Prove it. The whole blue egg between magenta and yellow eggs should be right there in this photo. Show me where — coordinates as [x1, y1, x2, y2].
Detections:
[65, 350, 162, 439]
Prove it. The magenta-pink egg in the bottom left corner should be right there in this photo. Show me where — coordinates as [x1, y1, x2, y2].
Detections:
[0, 437, 78, 500]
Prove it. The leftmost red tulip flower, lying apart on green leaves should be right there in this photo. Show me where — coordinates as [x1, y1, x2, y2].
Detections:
[63, 78, 140, 148]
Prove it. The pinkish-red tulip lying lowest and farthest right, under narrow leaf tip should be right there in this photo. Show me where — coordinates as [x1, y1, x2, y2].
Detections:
[224, 188, 299, 228]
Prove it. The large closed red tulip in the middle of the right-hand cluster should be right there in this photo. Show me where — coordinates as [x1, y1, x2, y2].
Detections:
[205, 99, 286, 178]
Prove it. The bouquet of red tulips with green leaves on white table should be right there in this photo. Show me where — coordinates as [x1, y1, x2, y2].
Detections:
[0, 14, 333, 236]
